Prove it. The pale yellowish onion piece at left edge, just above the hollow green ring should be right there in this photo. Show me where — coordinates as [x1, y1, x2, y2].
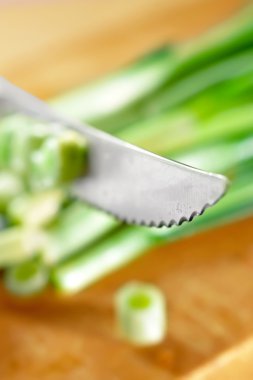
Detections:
[0, 227, 44, 267]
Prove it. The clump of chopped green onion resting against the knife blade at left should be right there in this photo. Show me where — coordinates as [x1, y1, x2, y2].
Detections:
[0, 115, 87, 190]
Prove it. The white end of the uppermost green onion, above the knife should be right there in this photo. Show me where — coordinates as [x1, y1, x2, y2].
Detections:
[52, 47, 174, 132]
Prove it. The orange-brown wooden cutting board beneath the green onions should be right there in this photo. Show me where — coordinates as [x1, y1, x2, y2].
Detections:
[0, 0, 253, 380]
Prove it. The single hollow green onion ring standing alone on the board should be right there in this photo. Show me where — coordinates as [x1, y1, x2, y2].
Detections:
[115, 282, 167, 346]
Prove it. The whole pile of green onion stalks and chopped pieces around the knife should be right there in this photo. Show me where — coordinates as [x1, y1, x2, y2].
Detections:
[0, 7, 253, 295]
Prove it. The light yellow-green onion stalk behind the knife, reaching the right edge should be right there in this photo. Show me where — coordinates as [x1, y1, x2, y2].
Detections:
[117, 104, 253, 156]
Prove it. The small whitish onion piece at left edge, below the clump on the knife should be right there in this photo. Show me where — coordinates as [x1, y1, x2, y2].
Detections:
[0, 172, 24, 210]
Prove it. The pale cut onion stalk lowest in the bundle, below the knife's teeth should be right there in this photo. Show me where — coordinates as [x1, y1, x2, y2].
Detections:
[52, 223, 153, 293]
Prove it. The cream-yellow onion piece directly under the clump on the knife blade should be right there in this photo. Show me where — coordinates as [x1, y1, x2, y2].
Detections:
[7, 189, 64, 226]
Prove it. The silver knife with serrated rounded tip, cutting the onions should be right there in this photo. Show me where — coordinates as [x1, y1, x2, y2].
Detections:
[0, 78, 228, 227]
